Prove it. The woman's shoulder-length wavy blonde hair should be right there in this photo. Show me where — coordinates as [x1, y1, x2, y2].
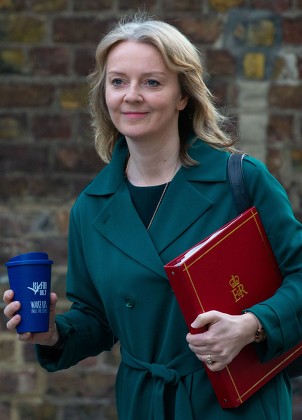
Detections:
[88, 15, 234, 165]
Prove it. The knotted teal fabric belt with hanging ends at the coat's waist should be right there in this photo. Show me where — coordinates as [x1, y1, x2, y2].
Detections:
[121, 349, 203, 420]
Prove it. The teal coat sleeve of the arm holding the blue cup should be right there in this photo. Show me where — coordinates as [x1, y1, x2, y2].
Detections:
[36, 203, 116, 371]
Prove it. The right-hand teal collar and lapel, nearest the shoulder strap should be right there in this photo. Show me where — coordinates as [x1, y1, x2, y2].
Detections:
[150, 141, 228, 252]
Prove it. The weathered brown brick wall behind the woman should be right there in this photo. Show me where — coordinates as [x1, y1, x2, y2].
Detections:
[0, 0, 302, 420]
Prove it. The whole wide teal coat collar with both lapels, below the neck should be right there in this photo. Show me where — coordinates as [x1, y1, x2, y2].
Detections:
[84, 136, 227, 277]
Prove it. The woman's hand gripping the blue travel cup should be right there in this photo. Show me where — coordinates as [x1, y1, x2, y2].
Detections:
[3, 290, 59, 346]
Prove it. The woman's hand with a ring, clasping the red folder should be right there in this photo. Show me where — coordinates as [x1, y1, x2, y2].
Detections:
[186, 311, 258, 371]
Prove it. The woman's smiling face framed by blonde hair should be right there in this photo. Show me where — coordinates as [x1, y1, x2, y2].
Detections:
[106, 41, 187, 144]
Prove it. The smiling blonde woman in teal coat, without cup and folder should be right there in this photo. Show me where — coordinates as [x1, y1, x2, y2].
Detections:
[4, 17, 302, 420]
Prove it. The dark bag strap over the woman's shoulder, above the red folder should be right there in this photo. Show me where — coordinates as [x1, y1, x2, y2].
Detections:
[228, 153, 252, 214]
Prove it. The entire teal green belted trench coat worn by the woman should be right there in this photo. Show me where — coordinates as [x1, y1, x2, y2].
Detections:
[37, 137, 302, 420]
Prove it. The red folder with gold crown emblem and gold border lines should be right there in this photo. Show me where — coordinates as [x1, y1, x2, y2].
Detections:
[165, 207, 302, 408]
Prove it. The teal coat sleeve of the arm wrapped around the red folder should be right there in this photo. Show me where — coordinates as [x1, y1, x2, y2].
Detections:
[244, 157, 302, 361]
